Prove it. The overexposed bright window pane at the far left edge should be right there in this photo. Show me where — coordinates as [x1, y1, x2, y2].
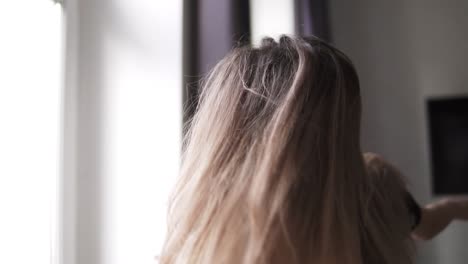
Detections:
[0, 0, 62, 264]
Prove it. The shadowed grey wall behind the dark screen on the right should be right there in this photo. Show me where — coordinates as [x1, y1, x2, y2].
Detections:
[330, 0, 468, 264]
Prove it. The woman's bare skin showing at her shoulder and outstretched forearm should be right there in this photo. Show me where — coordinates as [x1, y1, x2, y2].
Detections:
[364, 153, 468, 240]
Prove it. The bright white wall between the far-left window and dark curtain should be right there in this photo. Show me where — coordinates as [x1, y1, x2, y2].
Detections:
[62, 0, 182, 264]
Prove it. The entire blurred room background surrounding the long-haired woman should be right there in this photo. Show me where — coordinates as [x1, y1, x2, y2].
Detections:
[0, 0, 468, 264]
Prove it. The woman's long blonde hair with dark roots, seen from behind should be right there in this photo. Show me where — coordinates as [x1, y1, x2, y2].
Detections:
[161, 36, 411, 264]
